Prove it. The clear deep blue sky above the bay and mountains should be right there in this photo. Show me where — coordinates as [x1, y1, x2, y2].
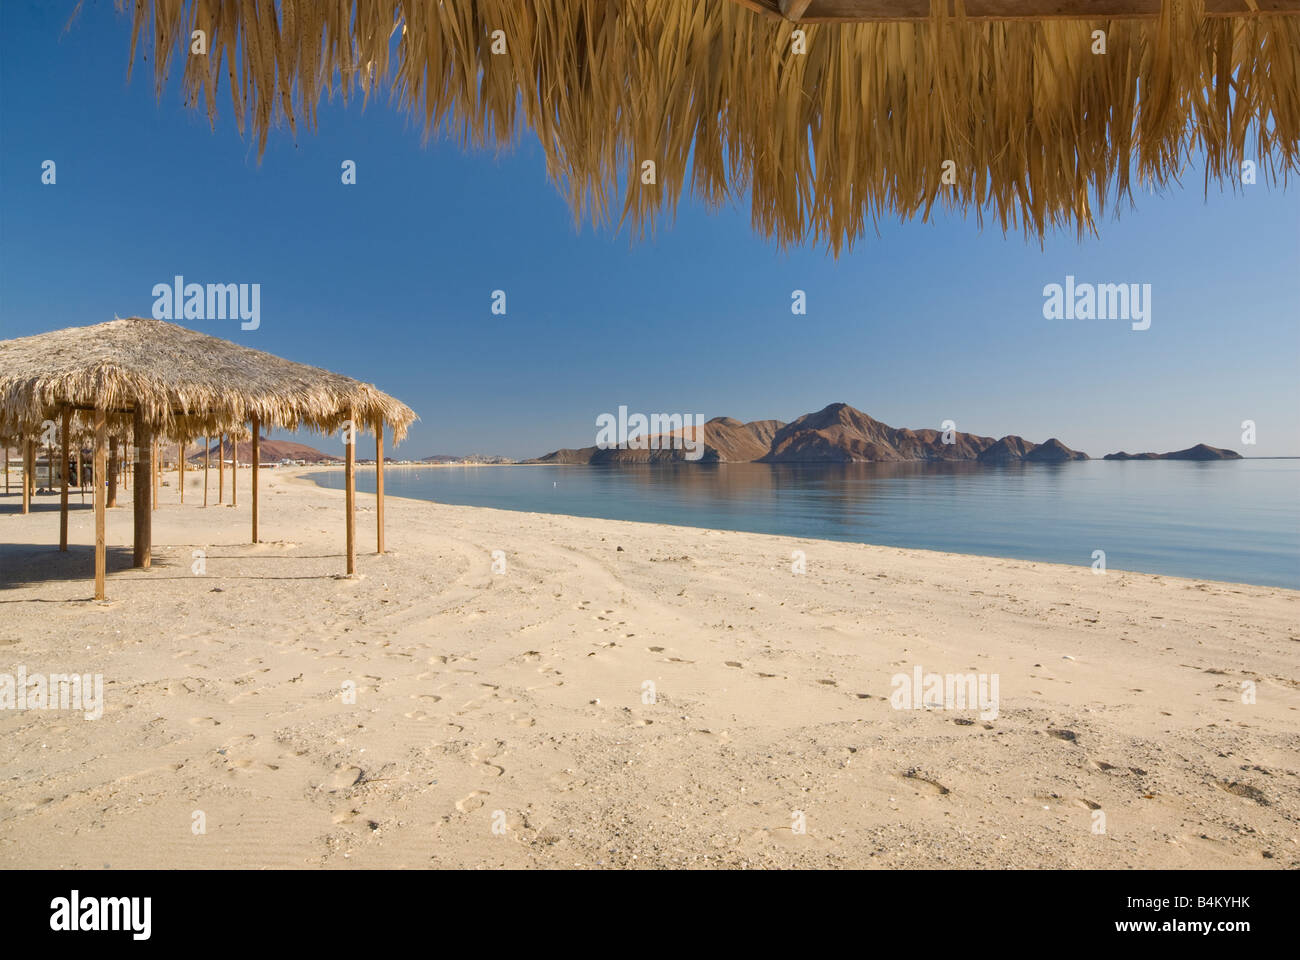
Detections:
[0, 0, 1300, 457]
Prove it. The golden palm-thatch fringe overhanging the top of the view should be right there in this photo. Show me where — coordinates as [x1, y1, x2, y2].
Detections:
[118, 0, 1300, 252]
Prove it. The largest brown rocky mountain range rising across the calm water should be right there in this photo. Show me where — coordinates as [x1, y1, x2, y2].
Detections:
[533, 403, 1088, 463]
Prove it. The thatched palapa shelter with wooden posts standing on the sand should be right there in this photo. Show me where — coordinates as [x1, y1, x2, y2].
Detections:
[0, 317, 416, 600]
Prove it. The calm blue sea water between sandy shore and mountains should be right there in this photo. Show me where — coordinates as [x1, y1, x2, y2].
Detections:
[315, 460, 1300, 588]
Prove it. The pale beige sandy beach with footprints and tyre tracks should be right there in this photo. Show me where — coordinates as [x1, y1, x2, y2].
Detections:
[0, 468, 1300, 868]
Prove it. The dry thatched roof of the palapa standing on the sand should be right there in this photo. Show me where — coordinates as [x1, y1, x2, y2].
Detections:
[0, 317, 416, 441]
